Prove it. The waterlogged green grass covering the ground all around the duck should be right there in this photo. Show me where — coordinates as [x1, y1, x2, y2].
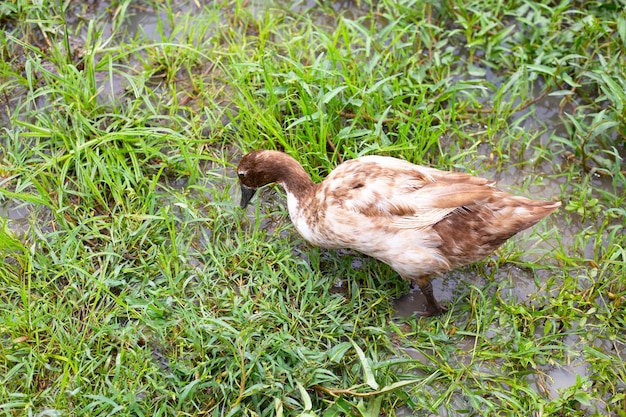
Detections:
[0, 0, 626, 417]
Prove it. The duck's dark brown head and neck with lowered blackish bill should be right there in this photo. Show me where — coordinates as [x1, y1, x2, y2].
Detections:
[237, 150, 313, 208]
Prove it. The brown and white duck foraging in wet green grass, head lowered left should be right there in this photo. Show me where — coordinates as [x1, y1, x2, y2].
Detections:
[237, 149, 561, 316]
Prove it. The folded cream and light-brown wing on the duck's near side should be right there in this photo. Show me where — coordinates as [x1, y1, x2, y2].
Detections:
[332, 160, 496, 229]
